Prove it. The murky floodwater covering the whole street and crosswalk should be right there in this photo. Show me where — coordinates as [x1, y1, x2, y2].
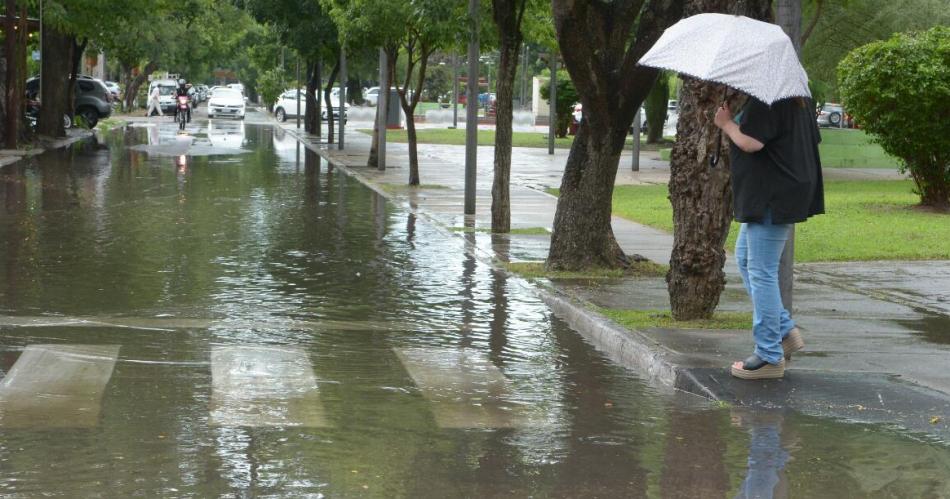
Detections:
[0, 123, 950, 498]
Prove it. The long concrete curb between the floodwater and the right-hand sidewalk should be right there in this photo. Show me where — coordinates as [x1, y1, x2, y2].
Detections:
[274, 124, 720, 401]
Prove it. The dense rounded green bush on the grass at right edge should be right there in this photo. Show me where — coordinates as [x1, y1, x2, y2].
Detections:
[838, 26, 950, 211]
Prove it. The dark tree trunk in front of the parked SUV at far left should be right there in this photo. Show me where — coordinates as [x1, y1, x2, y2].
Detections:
[36, 25, 73, 137]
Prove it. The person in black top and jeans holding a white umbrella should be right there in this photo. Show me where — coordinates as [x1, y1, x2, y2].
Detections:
[639, 14, 824, 379]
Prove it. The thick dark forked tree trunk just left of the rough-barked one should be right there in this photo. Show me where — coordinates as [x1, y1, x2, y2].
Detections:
[547, 0, 682, 270]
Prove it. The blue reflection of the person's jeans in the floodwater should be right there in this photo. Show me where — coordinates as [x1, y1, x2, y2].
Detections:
[732, 409, 791, 499]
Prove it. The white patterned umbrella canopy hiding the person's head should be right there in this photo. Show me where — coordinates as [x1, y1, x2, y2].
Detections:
[639, 14, 811, 105]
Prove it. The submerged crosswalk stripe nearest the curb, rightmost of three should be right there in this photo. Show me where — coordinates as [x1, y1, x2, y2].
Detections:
[393, 348, 527, 428]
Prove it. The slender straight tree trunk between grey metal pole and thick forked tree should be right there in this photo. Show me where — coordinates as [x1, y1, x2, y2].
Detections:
[491, 0, 527, 232]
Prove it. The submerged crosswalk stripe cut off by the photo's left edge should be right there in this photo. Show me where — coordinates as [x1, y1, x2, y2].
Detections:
[0, 345, 119, 428]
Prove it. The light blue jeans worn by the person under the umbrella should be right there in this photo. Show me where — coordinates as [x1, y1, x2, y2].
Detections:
[736, 212, 795, 364]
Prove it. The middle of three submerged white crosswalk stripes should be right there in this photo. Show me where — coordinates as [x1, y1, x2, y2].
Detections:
[211, 345, 329, 427]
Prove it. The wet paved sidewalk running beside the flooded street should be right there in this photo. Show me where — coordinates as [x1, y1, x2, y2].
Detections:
[282, 120, 950, 435]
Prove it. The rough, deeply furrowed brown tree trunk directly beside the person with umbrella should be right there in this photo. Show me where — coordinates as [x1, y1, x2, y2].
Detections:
[666, 0, 771, 320]
